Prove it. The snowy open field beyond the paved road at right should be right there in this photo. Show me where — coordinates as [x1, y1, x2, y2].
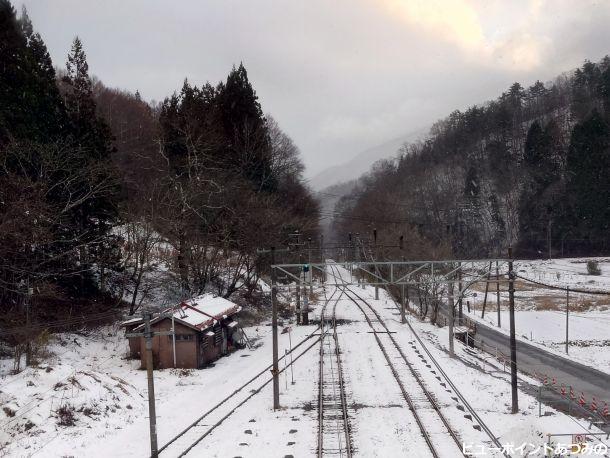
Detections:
[464, 258, 610, 373]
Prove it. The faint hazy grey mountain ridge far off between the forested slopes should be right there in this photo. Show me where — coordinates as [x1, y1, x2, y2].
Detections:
[309, 128, 429, 191]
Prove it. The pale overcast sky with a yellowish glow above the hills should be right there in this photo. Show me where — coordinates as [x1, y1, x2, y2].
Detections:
[15, 0, 610, 176]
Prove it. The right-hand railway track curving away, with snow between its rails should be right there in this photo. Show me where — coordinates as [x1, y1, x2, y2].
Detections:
[333, 264, 468, 458]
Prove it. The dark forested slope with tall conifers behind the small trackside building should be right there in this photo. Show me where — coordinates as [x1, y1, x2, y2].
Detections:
[0, 0, 318, 325]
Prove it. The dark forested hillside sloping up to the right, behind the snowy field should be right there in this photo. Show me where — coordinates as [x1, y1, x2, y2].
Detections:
[334, 57, 610, 257]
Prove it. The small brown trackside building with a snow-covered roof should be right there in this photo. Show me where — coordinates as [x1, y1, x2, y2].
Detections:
[123, 294, 242, 369]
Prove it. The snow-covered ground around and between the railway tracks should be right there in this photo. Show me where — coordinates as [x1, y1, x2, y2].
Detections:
[0, 260, 610, 458]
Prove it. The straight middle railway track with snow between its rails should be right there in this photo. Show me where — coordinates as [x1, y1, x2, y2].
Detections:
[317, 289, 352, 458]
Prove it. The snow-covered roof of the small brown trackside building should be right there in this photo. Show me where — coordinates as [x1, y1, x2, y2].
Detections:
[168, 294, 241, 329]
